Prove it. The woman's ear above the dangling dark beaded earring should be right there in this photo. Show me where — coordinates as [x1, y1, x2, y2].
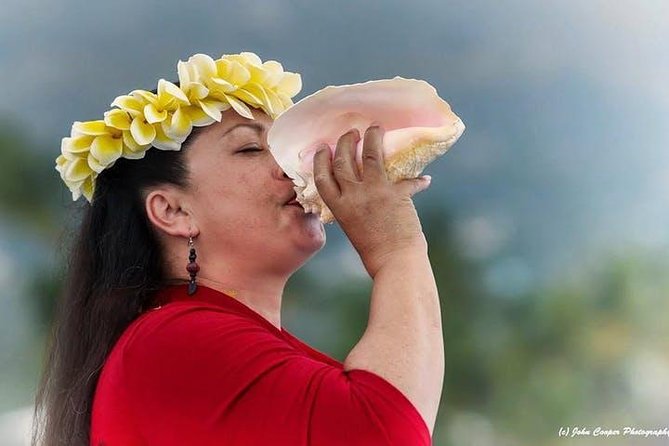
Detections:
[144, 187, 198, 237]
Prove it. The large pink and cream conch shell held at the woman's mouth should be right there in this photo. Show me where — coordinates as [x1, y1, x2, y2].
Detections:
[267, 77, 465, 223]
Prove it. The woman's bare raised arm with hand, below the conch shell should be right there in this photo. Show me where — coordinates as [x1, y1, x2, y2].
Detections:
[314, 127, 444, 433]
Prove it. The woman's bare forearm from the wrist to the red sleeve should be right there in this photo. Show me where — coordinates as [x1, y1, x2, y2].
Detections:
[344, 237, 444, 433]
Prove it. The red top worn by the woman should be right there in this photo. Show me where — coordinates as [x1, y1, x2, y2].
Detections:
[91, 285, 432, 446]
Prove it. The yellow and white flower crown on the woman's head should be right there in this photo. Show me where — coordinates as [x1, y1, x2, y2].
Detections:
[56, 52, 302, 202]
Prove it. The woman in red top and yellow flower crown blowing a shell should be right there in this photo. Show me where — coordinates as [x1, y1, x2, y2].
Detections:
[34, 53, 444, 446]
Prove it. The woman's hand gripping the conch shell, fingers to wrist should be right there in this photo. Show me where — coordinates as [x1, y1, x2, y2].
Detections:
[314, 126, 430, 278]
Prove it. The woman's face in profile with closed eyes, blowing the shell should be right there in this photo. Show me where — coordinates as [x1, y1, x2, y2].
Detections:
[186, 109, 325, 272]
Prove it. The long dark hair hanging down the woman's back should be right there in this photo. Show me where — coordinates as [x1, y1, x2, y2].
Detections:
[32, 125, 200, 446]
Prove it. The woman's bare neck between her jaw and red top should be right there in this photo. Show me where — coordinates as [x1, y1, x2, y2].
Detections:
[197, 274, 287, 330]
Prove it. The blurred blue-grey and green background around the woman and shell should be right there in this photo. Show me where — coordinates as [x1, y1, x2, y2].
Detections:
[0, 0, 669, 446]
